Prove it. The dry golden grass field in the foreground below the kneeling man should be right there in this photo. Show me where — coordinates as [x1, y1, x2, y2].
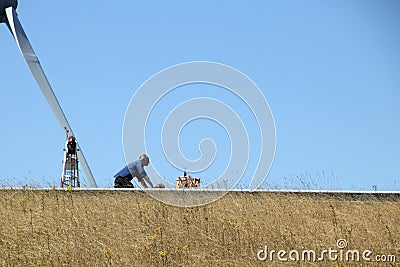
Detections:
[0, 190, 400, 266]
